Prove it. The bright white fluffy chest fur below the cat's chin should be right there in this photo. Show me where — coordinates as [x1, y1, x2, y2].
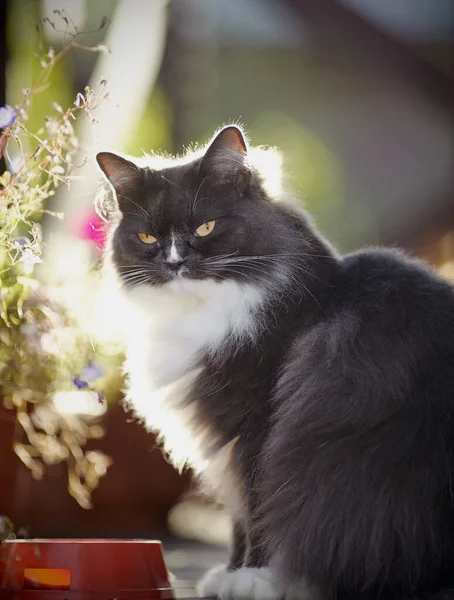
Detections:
[119, 280, 266, 471]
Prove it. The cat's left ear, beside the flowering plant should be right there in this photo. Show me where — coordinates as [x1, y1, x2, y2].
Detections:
[96, 152, 142, 210]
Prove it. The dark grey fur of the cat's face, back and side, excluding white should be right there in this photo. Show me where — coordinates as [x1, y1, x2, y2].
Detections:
[99, 126, 454, 600]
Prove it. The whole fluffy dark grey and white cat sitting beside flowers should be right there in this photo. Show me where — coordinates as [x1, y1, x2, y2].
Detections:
[97, 125, 454, 600]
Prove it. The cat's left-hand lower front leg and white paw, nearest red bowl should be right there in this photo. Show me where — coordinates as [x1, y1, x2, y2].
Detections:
[198, 521, 247, 598]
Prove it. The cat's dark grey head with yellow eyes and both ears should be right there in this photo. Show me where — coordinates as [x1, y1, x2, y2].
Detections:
[97, 126, 306, 288]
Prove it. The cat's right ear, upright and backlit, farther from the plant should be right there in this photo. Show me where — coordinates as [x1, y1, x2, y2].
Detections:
[200, 125, 249, 181]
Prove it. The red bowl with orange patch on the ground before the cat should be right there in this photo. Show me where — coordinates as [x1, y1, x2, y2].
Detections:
[0, 540, 175, 600]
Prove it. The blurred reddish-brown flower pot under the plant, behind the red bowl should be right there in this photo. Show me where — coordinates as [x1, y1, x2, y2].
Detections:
[0, 404, 189, 539]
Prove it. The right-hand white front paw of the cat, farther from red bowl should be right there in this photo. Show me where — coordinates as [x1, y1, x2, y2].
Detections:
[219, 567, 285, 600]
